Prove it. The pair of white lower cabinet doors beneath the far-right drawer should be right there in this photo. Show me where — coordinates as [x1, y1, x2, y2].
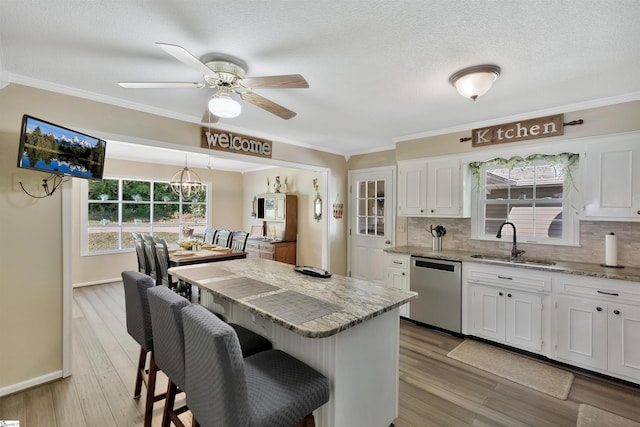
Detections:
[556, 295, 640, 381]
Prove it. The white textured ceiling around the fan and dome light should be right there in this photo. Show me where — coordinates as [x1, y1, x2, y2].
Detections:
[0, 0, 640, 170]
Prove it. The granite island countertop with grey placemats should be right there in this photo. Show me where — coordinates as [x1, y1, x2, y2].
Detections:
[169, 258, 418, 338]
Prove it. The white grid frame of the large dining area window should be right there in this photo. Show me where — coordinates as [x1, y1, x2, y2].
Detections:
[80, 176, 212, 256]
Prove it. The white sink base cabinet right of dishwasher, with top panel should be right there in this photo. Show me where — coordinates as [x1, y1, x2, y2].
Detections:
[462, 263, 551, 354]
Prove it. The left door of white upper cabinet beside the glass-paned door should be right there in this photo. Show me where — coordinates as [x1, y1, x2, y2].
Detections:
[398, 161, 427, 216]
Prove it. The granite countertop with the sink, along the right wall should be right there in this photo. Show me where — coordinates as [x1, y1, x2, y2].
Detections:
[385, 246, 640, 282]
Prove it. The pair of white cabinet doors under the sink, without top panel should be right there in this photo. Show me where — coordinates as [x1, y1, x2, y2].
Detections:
[470, 284, 542, 353]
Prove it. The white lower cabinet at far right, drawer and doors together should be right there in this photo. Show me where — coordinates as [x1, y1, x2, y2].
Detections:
[556, 276, 640, 382]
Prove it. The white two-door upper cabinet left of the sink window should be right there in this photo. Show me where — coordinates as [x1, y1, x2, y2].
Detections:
[398, 159, 468, 218]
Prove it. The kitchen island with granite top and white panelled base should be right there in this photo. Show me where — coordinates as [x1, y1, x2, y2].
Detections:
[170, 259, 417, 427]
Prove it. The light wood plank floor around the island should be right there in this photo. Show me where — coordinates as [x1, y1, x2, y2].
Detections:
[0, 284, 640, 427]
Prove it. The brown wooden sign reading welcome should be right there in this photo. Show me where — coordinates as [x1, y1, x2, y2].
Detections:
[200, 127, 272, 159]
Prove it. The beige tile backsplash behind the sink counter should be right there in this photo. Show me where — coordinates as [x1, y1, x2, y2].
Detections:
[408, 217, 640, 268]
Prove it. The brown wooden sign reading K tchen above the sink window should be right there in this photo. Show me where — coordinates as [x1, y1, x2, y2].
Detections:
[471, 114, 564, 147]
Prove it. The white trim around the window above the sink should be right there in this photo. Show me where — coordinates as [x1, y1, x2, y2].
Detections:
[471, 156, 583, 246]
